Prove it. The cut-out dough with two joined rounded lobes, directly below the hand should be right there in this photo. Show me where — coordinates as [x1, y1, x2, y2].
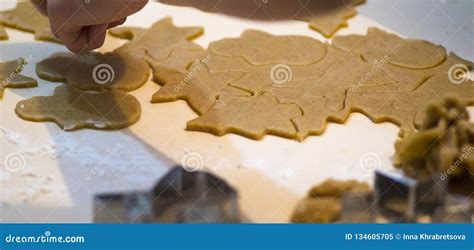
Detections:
[21, 52, 146, 131]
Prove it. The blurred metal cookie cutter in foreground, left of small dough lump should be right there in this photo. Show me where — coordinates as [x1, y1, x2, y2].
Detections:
[94, 167, 239, 223]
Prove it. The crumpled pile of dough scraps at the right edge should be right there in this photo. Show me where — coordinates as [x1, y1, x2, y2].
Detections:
[395, 97, 474, 195]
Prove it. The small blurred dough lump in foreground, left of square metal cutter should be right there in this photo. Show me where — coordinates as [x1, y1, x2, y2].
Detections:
[291, 179, 371, 223]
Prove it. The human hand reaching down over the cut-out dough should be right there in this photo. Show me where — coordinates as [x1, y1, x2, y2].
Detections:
[31, 0, 148, 53]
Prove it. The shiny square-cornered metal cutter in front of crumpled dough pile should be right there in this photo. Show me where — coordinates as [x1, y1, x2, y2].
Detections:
[374, 170, 447, 222]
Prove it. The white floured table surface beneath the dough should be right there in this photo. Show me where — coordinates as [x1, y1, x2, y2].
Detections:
[0, 0, 474, 222]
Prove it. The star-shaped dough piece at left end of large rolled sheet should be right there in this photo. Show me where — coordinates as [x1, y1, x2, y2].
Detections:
[109, 17, 204, 85]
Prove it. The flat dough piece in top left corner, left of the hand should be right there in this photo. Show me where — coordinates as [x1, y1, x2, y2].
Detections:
[0, 1, 62, 43]
